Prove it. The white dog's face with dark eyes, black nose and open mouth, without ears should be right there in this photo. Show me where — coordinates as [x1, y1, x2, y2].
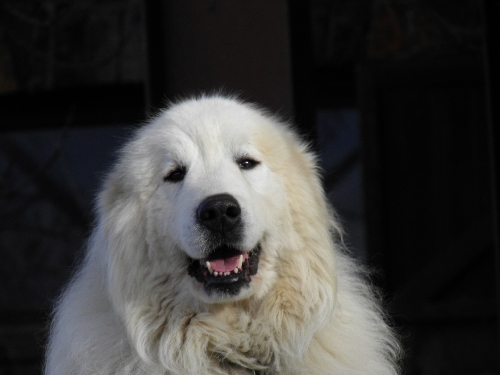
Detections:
[142, 99, 286, 302]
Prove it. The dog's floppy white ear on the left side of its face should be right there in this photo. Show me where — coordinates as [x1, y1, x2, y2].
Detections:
[93, 126, 170, 313]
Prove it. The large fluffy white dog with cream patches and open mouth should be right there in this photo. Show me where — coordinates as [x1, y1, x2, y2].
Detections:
[45, 96, 399, 375]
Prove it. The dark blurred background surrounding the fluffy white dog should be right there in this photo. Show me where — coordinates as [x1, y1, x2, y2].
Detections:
[0, 0, 500, 375]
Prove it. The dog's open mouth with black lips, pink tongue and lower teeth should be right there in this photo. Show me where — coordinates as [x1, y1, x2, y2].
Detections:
[188, 245, 260, 295]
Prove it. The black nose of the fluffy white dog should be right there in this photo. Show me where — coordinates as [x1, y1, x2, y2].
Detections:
[196, 194, 241, 233]
